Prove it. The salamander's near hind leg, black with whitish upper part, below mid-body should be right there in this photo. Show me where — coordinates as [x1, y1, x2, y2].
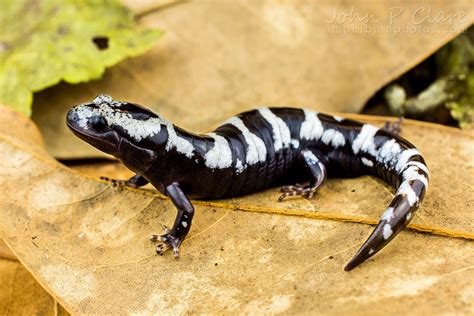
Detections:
[278, 150, 327, 202]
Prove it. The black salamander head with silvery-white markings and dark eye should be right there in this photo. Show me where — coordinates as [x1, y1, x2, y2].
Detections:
[66, 94, 166, 156]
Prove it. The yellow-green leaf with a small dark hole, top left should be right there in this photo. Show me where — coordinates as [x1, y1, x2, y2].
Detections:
[0, 0, 161, 115]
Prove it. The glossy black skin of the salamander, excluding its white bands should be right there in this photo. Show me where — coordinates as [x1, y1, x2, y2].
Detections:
[67, 103, 418, 270]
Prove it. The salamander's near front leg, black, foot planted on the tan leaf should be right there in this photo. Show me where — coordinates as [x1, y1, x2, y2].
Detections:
[150, 183, 194, 259]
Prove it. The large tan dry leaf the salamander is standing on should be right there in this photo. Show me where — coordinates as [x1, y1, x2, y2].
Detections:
[0, 103, 474, 314]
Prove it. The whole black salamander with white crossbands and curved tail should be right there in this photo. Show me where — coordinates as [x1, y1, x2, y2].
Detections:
[67, 95, 429, 271]
